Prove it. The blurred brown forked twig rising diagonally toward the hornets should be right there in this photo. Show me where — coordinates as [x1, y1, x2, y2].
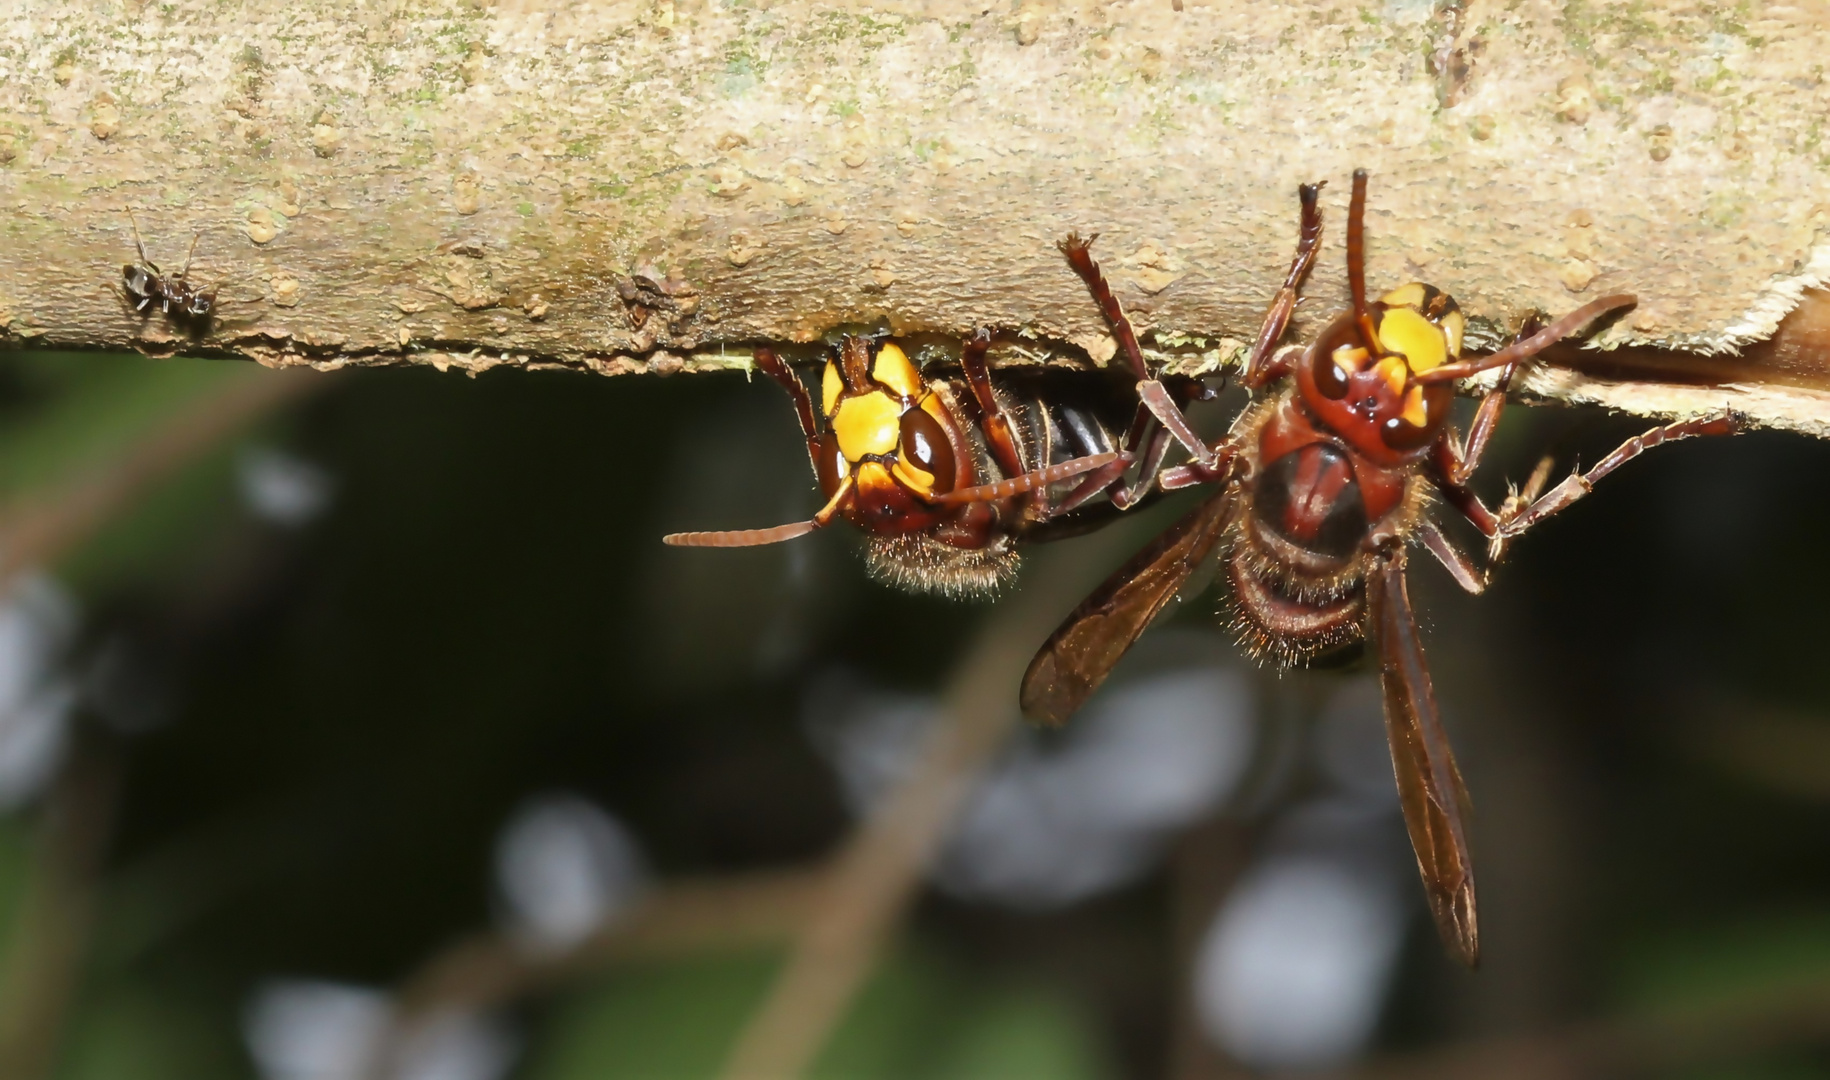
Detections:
[370, 527, 1136, 1076]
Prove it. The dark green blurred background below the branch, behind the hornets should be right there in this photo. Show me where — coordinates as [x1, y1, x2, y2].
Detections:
[0, 353, 1830, 1080]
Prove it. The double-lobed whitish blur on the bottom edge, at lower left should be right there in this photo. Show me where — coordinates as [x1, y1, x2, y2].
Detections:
[243, 979, 516, 1080]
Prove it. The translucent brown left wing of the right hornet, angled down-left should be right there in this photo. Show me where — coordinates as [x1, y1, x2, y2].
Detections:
[1021, 485, 1233, 723]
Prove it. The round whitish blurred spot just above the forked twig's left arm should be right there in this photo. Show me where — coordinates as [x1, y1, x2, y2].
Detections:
[496, 793, 646, 948]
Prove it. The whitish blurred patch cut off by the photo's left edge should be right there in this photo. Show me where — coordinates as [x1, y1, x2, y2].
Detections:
[0, 571, 79, 811]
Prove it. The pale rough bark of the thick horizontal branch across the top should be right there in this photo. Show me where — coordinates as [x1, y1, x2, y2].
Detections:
[0, 0, 1830, 434]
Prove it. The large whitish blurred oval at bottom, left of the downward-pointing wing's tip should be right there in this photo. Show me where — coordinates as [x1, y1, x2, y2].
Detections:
[1195, 853, 1405, 1069]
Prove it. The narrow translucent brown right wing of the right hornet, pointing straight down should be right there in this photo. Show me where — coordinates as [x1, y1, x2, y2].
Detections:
[1367, 555, 1480, 967]
